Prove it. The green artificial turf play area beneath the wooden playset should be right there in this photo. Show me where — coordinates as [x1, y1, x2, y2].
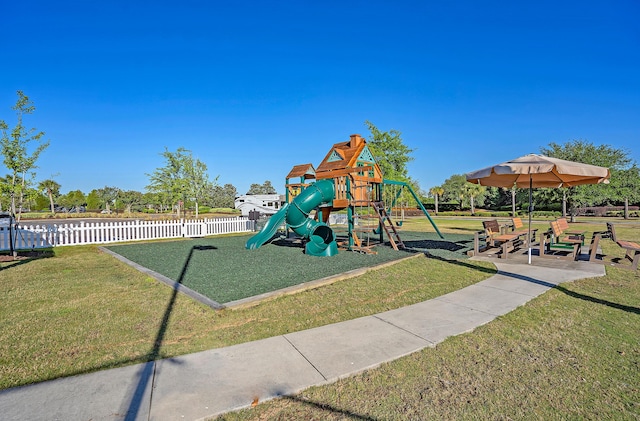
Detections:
[107, 228, 472, 304]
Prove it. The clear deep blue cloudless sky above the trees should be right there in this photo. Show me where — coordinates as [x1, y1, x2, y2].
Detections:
[0, 0, 640, 193]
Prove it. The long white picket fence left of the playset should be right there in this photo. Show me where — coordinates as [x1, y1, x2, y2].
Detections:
[0, 217, 255, 250]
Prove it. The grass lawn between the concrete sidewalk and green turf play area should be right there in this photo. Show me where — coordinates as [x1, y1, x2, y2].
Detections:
[0, 225, 495, 389]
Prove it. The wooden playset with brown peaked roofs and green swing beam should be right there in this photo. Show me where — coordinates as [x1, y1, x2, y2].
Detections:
[285, 134, 442, 253]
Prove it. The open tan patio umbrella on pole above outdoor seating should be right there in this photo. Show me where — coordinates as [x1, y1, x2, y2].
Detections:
[466, 154, 611, 264]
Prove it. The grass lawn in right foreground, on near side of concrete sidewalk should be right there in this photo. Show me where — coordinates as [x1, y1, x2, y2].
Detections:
[219, 268, 640, 421]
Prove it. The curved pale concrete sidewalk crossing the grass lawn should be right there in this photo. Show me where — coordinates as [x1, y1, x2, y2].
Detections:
[0, 259, 605, 420]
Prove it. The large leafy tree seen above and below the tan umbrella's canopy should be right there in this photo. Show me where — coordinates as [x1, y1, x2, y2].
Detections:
[540, 140, 635, 218]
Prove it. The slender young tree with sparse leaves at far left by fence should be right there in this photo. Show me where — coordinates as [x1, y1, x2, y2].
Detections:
[0, 91, 49, 221]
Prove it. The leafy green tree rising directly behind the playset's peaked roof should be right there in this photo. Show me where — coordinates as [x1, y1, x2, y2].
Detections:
[365, 121, 413, 181]
